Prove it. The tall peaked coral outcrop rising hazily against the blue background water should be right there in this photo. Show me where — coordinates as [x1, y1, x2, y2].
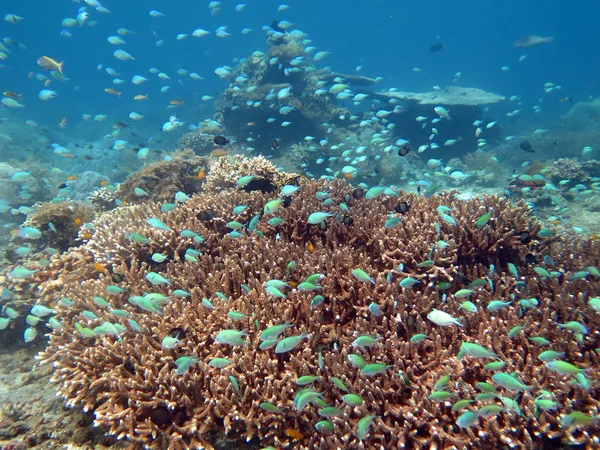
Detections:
[215, 33, 348, 154]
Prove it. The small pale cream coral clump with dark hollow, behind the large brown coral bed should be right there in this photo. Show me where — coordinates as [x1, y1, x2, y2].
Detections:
[204, 155, 300, 192]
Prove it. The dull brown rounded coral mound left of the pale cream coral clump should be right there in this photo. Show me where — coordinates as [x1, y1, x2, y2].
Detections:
[116, 150, 207, 204]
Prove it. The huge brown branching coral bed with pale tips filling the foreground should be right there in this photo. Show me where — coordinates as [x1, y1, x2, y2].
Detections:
[39, 181, 600, 449]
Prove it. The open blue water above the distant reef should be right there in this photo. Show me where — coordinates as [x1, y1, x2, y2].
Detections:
[0, 0, 600, 134]
